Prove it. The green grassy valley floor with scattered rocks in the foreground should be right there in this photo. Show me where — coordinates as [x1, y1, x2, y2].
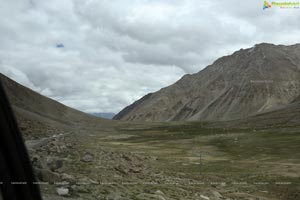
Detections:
[29, 123, 300, 200]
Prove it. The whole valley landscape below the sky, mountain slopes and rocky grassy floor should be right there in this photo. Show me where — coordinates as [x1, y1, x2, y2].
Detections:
[0, 43, 300, 200]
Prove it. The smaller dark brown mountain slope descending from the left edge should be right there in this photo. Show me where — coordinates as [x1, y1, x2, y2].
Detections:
[0, 73, 111, 138]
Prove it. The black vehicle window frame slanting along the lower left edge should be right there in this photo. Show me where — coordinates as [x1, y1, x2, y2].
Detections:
[0, 80, 42, 200]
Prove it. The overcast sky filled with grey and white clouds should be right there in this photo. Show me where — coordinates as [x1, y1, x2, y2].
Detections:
[0, 0, 300, 113]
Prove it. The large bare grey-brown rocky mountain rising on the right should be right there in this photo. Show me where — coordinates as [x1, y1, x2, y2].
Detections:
[114, 43, 300, 121]
